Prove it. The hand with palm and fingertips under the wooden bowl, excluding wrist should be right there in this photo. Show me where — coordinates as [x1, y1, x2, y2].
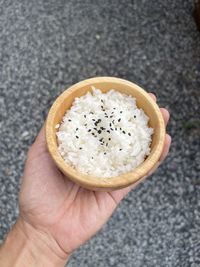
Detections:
[20, 94, 170, 255]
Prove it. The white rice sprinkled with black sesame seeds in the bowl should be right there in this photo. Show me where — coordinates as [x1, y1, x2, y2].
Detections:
[56, 87, 153, 177]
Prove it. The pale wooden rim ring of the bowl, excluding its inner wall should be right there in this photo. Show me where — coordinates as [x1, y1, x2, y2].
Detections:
[45, 76, 166, 190]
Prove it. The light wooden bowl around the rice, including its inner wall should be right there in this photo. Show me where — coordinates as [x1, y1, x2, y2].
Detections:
[46, 77, 165, 191]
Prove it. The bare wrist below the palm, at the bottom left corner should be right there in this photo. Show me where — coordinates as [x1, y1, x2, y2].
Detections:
[0, 218, 69, 267]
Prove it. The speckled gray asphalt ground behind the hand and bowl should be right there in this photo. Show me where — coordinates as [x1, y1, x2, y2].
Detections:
[0, 0, 200, 267]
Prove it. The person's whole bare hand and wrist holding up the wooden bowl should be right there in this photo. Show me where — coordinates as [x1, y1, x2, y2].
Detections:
[0, 94, 171, 267]
